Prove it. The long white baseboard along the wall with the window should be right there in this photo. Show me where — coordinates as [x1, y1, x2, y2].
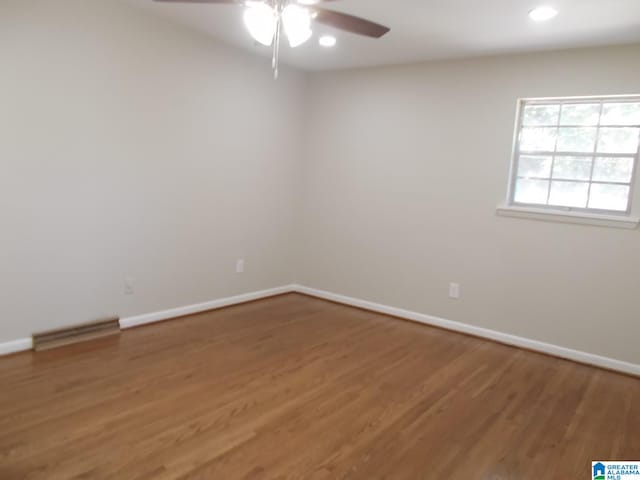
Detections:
[293, 285, 640, 376]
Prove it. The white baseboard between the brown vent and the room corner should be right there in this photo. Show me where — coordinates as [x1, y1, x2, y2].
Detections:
[120, 285, 294, 329]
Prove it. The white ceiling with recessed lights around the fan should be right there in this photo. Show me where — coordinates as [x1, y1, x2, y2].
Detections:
[126, 0, 640, 70]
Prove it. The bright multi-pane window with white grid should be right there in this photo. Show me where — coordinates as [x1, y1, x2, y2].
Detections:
[509, 96, 640, 215]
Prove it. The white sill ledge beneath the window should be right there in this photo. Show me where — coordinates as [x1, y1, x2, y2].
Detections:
[496, 205, 640, 230]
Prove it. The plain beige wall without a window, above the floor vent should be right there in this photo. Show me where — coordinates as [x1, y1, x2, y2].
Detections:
[0, 0, 305, 342]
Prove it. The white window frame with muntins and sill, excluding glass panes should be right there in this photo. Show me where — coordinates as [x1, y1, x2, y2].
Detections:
[498, 95, 640, 228]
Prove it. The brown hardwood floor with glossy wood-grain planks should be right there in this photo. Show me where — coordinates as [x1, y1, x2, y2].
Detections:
[0, 294, 640, 480]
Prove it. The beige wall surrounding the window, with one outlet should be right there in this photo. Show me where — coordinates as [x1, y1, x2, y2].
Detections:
[298, 45, 640, 363]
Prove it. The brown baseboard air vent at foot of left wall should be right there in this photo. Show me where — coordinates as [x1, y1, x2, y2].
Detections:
[33, 317, 120, 352]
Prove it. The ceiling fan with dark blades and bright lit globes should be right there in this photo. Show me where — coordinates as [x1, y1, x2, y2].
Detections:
[154, 0, 391, 78]
